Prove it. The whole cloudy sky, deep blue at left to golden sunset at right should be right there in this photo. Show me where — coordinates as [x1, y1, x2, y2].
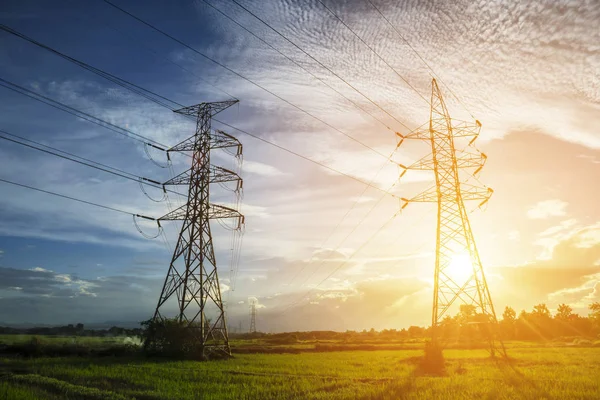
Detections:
[0, 0, 600, 332]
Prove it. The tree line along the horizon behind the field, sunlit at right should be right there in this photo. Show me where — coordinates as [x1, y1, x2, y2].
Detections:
[0, 302, 600, 344]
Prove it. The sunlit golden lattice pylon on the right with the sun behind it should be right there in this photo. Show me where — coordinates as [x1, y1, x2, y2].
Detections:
[398, 79, 505, 355]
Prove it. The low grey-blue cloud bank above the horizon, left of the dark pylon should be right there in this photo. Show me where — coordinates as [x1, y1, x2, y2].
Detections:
[0, 268, 164, 325]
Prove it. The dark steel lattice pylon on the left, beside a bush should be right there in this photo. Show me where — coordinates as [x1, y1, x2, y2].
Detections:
[149, 100, 244, 358]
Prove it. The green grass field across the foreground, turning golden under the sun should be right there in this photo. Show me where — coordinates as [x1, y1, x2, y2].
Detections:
[0, 340, 600, 400]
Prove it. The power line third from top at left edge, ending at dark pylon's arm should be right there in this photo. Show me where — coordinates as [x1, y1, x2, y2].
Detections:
[0, 129, 181, 195]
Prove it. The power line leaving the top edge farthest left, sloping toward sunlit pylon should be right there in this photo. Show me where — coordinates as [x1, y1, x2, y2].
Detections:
[103, 0, 394, 158]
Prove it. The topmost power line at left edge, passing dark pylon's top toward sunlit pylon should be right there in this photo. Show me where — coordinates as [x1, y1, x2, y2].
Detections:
[0, 24, 398, 198]
